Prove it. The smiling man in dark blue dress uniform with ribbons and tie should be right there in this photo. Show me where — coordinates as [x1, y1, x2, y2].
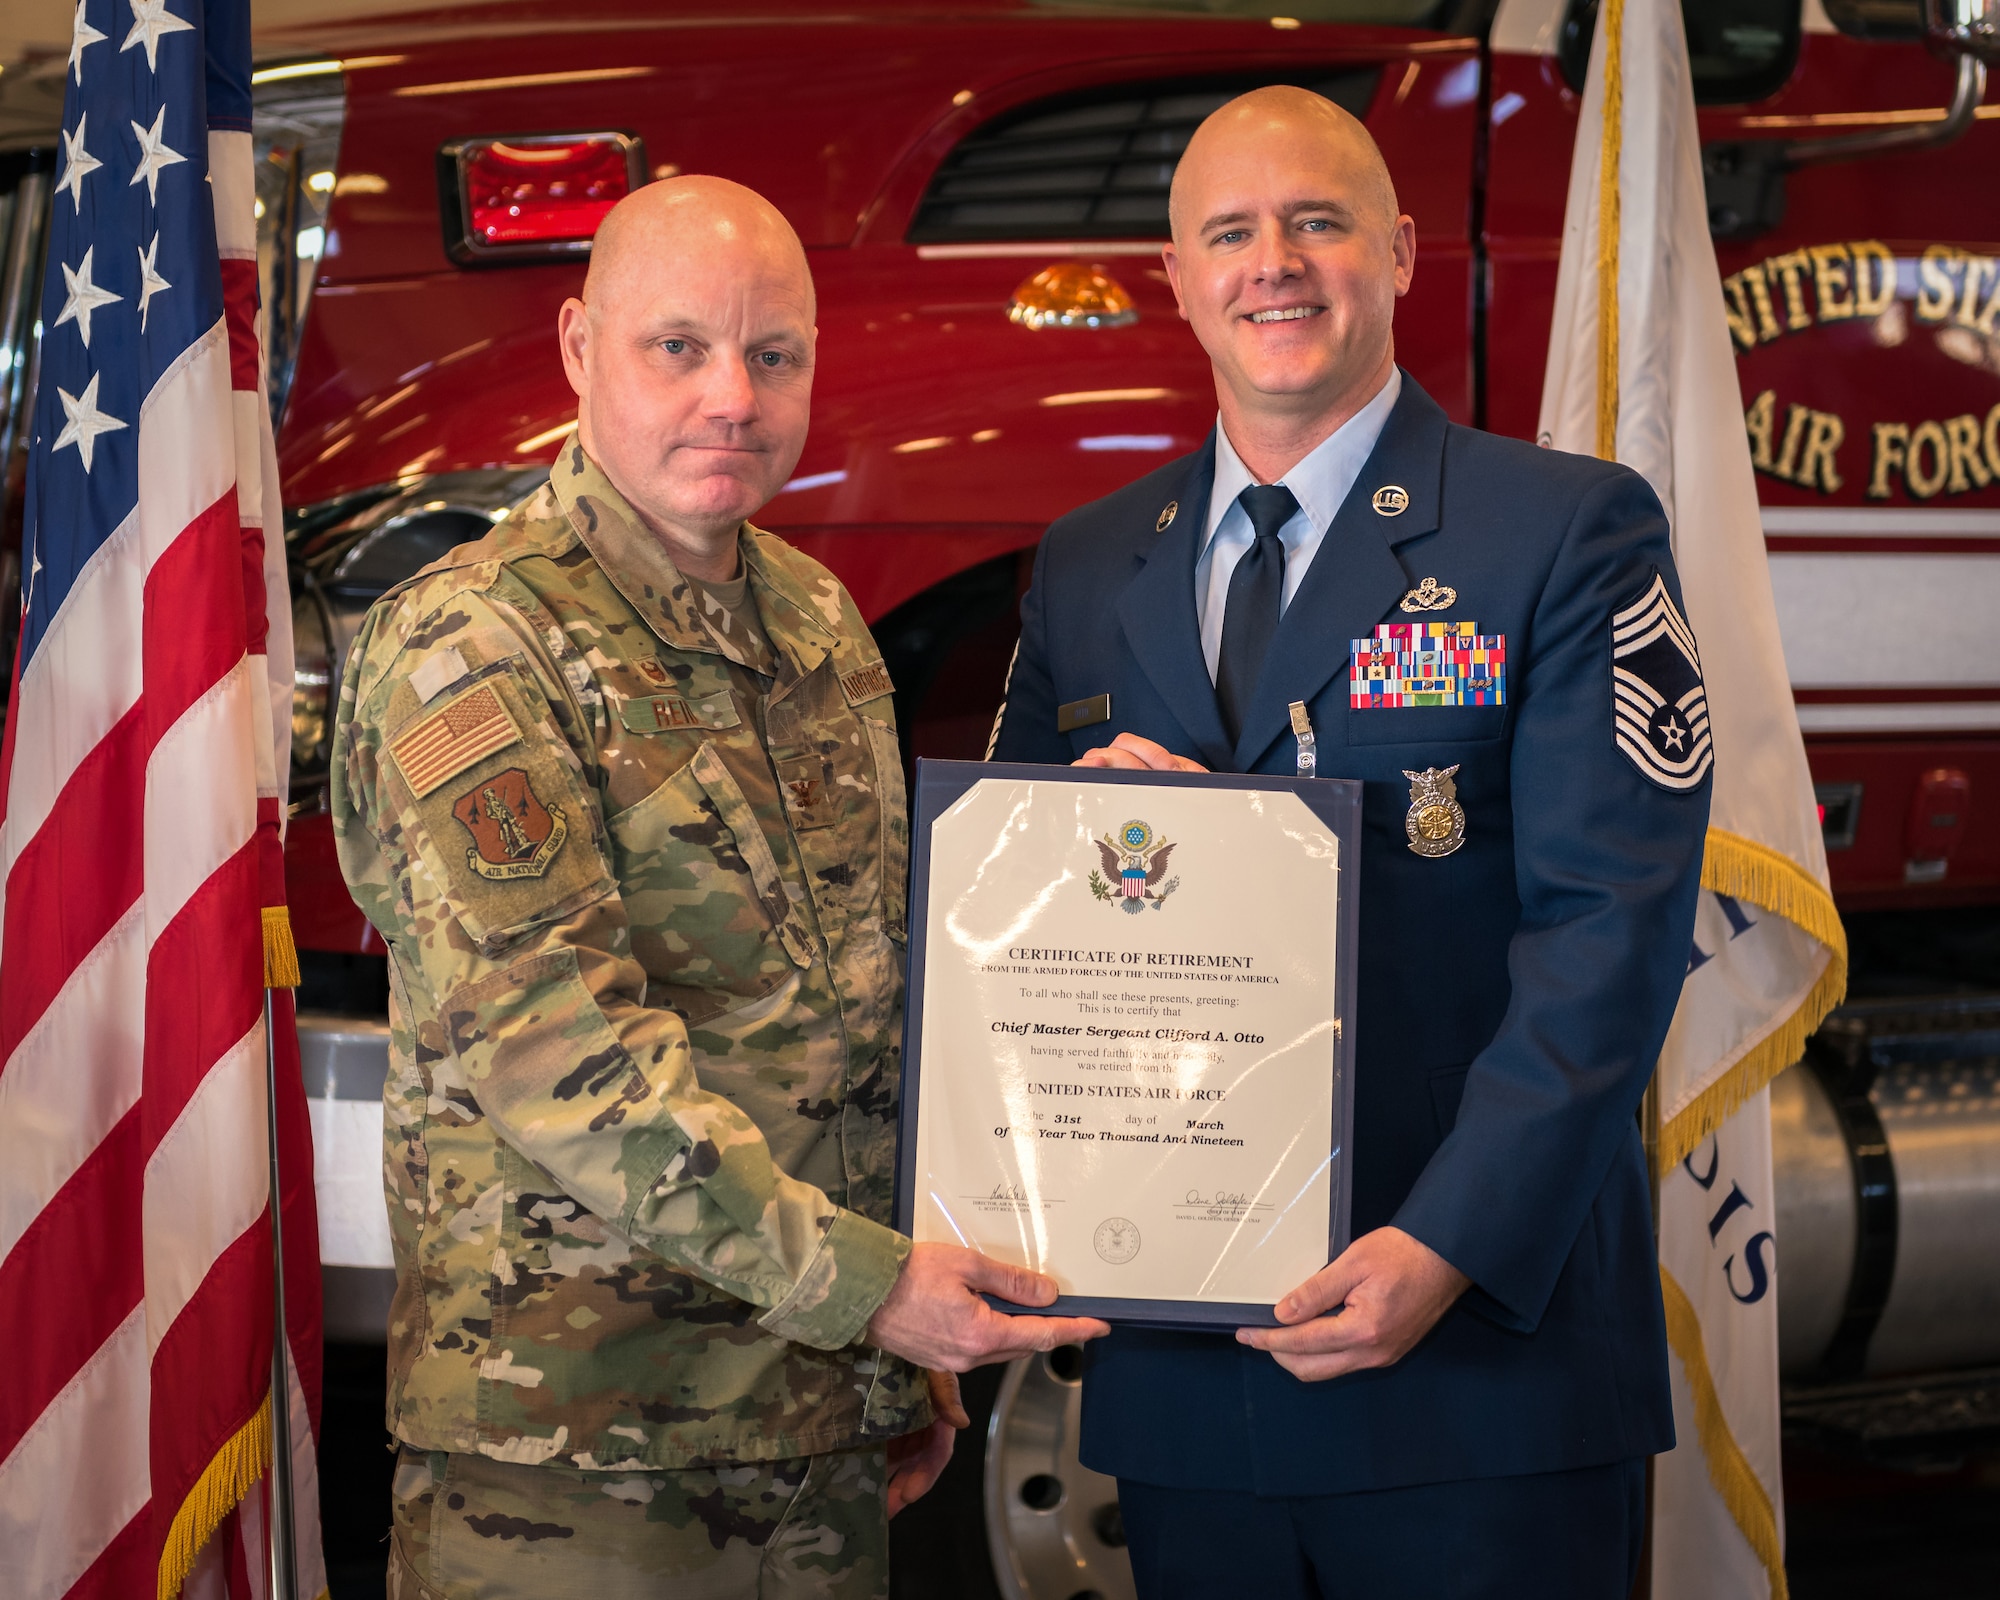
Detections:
[994, 88, 1710, 1600]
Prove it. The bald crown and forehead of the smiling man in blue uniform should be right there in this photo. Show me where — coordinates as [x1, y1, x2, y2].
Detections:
[1166, 84, 1398, 240]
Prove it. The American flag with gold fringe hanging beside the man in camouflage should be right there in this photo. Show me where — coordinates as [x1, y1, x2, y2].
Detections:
[0, 0, 326, 1600]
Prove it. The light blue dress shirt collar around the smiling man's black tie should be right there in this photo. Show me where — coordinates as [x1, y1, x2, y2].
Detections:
[1194, 366, 1402, 682]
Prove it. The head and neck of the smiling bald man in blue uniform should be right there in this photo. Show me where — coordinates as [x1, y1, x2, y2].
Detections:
[1162, 88, 1416, 484]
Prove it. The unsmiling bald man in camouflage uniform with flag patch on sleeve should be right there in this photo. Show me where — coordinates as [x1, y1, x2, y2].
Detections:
[332, 178, 1104, 1600]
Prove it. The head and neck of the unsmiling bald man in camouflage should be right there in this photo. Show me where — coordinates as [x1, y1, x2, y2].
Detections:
[558, 178, 818, 578]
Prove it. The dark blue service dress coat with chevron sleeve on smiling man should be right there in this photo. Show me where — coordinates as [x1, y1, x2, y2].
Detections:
[994, 374, 1708, 1494]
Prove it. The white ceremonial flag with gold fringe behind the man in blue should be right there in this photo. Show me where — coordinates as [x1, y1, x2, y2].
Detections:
[1540, 0, 1846, 1600]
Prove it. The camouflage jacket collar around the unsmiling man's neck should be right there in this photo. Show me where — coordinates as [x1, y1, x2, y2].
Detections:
[548, 436, 836, 676]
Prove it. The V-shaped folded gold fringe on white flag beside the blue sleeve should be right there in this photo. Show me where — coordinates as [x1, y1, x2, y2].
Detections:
[1656, 828, 1848, 1172]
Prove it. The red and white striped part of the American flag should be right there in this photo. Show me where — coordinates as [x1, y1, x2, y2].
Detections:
[0, 132, 324, 1600]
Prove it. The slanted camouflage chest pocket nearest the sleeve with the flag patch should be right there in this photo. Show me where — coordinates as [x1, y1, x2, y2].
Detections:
[606, 742, 814, 1022]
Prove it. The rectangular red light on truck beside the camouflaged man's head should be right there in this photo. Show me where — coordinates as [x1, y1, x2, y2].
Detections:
[440, 132, 646, 260]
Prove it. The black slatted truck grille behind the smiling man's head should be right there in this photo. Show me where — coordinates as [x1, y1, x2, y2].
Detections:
[910, 68, 1378, 244]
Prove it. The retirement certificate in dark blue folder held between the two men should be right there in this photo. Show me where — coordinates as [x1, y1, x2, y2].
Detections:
[898, 762, 1360, 1324]
